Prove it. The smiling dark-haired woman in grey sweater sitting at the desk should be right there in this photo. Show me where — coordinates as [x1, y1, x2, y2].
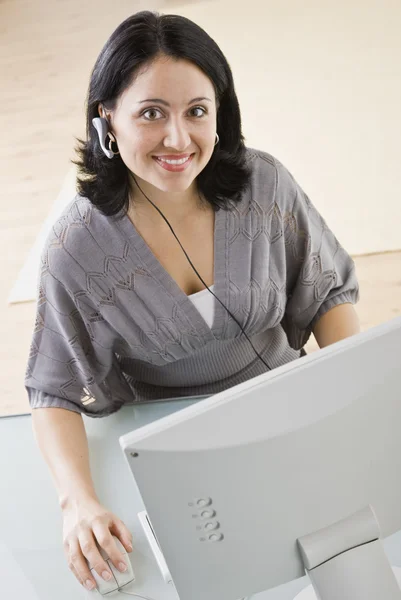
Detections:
[26, 12, 359, 589]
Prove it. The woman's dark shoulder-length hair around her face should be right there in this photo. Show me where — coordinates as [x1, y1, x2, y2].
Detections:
[72, 11, 250, 215]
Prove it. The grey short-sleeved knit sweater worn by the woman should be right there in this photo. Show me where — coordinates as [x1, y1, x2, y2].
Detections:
[25, 149, 358, 417]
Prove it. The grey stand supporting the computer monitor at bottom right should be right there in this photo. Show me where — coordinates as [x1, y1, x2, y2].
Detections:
[296, 506, 401, 600]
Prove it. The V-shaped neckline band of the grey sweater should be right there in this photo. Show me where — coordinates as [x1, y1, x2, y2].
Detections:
[116, 209, 228, 341]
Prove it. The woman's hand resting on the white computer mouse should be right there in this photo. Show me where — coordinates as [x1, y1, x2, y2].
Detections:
[62, 498, 132, 590]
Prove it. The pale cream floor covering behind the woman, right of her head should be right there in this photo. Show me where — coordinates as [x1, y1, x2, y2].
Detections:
[163, 0, 401, 254]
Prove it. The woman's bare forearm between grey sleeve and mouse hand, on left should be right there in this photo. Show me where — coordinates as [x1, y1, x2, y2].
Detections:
[32, 408, 97, 509]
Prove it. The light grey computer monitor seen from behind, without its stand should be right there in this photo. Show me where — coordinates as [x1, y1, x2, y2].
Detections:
[120, 318, 401, 600]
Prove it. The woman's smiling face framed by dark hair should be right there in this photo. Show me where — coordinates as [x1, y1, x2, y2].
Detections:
[101, 56, 216, 192]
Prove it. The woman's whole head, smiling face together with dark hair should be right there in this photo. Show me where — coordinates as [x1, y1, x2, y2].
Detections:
[71, 11, 250, 215]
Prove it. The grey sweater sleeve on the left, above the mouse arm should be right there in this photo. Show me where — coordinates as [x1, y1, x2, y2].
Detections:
[25, 245, 134, 417]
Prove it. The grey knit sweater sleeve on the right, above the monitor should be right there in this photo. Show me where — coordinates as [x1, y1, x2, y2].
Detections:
[276, 161, 359, 350]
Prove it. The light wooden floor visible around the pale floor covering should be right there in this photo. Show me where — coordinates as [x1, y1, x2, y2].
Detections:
[0, 0, 401, 416]
